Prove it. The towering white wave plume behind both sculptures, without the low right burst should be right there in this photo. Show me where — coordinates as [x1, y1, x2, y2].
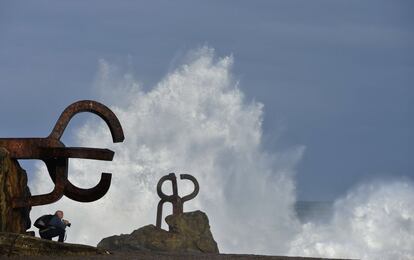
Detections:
[32, 48, 303, 253]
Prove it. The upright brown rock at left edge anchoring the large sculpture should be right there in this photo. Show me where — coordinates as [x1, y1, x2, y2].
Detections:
[0, 147, 31, 233]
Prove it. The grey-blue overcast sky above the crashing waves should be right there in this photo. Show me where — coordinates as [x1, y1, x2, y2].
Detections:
[0, 0, 414, 200]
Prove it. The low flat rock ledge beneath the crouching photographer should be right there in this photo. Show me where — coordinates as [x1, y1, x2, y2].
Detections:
[0, 232, 109, 256]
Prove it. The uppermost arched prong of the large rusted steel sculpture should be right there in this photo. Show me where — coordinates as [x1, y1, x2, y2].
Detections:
[48, 100, 125, 143]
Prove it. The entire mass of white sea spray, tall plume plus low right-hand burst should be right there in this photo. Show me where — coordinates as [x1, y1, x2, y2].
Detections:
[27, 48, 414, 259]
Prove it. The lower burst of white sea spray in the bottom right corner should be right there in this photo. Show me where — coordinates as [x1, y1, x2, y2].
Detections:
[289, 181, 414, 260]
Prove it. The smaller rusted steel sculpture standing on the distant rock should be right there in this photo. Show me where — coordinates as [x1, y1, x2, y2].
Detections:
[156, 173, 200, 228]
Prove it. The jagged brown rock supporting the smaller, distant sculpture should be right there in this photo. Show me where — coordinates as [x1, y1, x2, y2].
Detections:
[98, 211, 219, 253]
